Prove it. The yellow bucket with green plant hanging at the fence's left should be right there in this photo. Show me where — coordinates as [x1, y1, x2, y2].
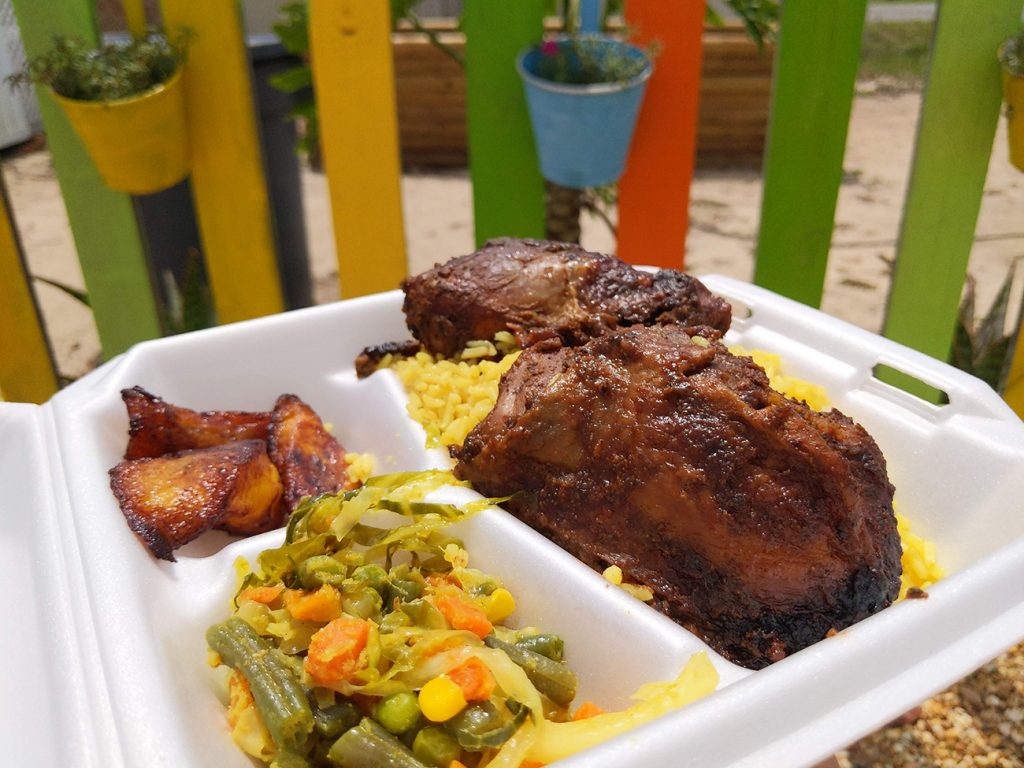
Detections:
[10, 33, 189, 195]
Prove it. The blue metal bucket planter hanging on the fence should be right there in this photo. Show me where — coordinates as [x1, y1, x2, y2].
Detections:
[516, 36, 653, 189]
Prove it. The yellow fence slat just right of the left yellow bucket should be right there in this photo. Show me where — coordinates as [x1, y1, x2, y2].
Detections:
[163, 0, 285, 323]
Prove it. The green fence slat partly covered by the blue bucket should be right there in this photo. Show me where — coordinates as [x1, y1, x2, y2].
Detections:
[462, 0, 545, 245]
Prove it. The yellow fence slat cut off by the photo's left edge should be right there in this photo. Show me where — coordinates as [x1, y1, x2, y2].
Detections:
[0, 180, 57, 402]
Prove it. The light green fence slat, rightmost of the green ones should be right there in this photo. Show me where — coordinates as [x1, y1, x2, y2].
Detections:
[880, 0, 1022, 360]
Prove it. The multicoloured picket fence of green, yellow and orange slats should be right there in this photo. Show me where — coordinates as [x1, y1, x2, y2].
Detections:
[6, 0, 1024, 421]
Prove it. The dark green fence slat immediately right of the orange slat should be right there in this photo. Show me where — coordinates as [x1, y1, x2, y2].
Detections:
[754, 0, 867, 306]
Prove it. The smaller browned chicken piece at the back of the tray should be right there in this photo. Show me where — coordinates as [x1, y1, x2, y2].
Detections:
[402, 239, 731, 355]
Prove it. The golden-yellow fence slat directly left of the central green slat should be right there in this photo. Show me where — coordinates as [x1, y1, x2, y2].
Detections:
[309, 0, 408, 298]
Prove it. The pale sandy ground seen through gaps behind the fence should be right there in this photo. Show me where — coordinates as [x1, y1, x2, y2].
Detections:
[3, 84, 1024, 377]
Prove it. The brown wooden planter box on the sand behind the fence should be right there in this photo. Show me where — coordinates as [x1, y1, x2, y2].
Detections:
[393, 27, 773, 168]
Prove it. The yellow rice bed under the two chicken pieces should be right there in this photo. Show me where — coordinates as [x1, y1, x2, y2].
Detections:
[381, 339, 944, 599]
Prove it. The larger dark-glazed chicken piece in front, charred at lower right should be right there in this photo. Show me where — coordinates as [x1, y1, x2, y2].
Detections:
[453, 326, 901, 669]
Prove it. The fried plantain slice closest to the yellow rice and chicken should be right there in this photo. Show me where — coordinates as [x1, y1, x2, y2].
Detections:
[270, 394, 355, 511]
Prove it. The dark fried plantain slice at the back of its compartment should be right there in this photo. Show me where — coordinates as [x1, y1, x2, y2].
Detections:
[121, 386, 270, 459]
